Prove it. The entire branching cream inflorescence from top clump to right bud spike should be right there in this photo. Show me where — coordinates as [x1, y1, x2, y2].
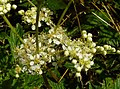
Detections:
[15, 7, 120, 77]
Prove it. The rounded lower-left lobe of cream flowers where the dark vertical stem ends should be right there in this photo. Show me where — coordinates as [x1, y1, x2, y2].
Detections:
[16, 36, 55, 74]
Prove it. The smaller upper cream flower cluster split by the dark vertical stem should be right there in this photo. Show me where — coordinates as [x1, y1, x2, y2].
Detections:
[18, 7, 53, 30]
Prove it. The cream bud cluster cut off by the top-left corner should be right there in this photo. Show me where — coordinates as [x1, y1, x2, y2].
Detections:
[0, 0, 17, 15]
